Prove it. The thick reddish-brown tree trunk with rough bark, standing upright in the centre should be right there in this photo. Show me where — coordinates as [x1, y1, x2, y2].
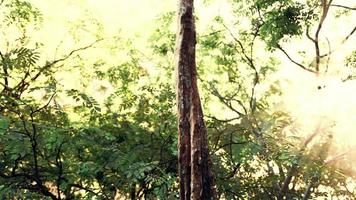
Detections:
[176, 0, 217, 200]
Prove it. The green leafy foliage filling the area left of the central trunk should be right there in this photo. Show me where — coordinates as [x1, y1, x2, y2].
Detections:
[0, 1, 177, 199]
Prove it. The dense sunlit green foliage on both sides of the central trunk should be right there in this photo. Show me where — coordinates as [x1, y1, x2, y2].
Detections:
[0, 0, 356, 199]
